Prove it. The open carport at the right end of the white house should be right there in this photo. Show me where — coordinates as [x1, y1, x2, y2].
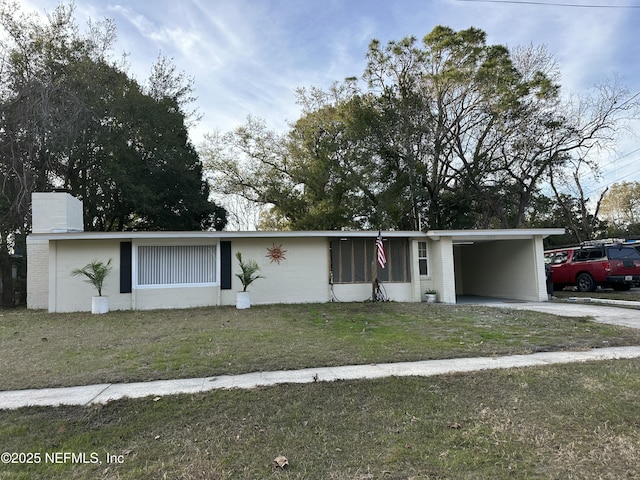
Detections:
[427, 228, 564, 302]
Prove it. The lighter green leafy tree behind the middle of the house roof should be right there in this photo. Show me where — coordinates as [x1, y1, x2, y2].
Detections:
[288, 82, 386, 230]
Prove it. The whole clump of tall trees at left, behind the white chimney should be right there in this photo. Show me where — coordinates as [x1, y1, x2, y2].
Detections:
[0, 2, 226, 231]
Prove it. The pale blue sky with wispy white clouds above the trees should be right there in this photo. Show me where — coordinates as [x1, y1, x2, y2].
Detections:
[21, 0, 640, 197]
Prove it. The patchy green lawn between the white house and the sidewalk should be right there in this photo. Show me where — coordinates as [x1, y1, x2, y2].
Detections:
[0, 303, 640, 390]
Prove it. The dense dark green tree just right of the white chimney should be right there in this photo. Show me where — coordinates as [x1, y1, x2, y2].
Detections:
[68, 59, 225, 230]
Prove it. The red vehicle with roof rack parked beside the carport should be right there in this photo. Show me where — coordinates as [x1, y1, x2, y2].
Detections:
[544, 244, 640, 292]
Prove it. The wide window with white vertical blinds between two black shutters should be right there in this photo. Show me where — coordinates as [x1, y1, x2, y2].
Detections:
[137, 245, 216, 286]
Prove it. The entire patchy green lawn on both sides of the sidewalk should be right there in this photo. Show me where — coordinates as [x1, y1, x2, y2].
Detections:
[0, 303, 640, 480]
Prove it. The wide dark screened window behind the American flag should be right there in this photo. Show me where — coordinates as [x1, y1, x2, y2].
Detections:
[331, 238, 411, 283]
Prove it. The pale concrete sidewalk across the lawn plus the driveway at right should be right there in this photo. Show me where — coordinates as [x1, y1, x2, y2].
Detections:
[0, 302, 640, 409]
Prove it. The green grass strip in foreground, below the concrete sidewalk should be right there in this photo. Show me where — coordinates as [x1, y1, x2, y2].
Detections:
[0, 360, 640, 480]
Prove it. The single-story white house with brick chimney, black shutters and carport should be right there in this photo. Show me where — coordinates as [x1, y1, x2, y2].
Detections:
[27, 192, 564, 312]
